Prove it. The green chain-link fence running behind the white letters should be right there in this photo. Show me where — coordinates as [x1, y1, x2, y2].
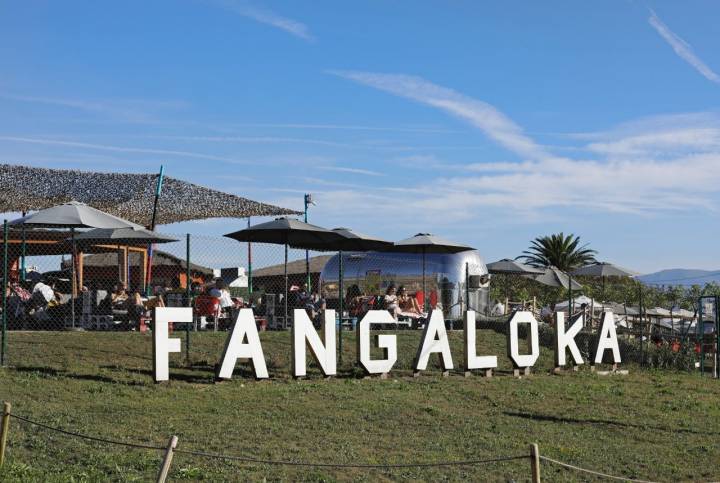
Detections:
[3, 229, 718, 371]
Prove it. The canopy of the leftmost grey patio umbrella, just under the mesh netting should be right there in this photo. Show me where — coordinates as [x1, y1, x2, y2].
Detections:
[9, 201, 142, 228]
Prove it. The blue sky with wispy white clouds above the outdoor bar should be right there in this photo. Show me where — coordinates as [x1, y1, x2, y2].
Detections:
[0, 0, 720, 272]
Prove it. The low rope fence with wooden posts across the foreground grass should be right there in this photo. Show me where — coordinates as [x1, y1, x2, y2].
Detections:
[0, 402, 716, 483]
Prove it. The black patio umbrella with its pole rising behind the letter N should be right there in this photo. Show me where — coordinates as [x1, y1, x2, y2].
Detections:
[224, 217, 343, 324]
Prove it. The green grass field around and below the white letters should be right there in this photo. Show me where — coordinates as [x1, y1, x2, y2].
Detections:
[0, 331, 720, 481]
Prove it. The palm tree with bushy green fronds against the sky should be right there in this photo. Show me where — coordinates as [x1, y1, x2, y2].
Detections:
[517, 232, 597, 272]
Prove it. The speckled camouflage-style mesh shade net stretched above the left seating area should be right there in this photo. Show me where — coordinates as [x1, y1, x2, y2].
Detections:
[0, 164, 299, 225]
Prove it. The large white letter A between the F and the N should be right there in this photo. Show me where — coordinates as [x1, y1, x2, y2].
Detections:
[217, 309, 268, 379]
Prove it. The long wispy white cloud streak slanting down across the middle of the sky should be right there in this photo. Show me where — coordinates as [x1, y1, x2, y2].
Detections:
[330, 71, 549, 159]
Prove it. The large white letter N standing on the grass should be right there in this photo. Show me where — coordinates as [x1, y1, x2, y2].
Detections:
[292, 309, 337, 377]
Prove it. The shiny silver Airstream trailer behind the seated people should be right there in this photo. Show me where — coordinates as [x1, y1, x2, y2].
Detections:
[320, 250, 489, 320]
